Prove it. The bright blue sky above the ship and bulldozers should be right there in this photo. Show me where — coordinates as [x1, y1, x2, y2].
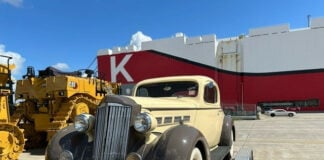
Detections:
[0, 0, 324, 79]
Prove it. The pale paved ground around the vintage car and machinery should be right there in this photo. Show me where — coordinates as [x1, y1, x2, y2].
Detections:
[19, 113, 324, 160]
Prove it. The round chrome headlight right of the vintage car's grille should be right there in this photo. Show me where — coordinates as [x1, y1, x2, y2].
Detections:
[134, 113, 157, 133]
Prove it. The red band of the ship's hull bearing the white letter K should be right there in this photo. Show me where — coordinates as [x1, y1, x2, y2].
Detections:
[97, 51, 324, 111]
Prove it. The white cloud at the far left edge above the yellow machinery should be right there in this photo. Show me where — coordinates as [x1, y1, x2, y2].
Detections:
[0, 44, 25, 76]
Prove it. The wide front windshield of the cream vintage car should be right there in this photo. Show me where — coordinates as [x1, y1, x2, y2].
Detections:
[136, 81, 198, 97]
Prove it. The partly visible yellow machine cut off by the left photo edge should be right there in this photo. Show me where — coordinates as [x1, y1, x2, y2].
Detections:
[0, 55, 25, 160]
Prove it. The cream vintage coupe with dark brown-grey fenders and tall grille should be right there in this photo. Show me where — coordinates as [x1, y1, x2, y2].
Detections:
[46, 76, 235, 160]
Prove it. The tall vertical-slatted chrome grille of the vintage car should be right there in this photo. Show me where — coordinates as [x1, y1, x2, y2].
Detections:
[93, 103, 131, 160]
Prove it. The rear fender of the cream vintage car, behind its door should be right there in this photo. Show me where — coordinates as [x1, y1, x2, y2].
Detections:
[219, 116, 235, 146]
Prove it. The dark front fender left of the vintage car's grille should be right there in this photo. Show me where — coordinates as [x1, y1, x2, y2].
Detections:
[45, 125, 92, 160]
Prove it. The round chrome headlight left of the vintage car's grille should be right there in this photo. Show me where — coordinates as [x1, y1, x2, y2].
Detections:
[74, 113, 95, 132]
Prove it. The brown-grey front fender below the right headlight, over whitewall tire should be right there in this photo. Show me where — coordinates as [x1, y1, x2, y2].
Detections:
[145, 125, 210, 160]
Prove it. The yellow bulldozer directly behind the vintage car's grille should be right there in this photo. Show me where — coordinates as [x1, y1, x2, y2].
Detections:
[11, 67, 120, 149]
